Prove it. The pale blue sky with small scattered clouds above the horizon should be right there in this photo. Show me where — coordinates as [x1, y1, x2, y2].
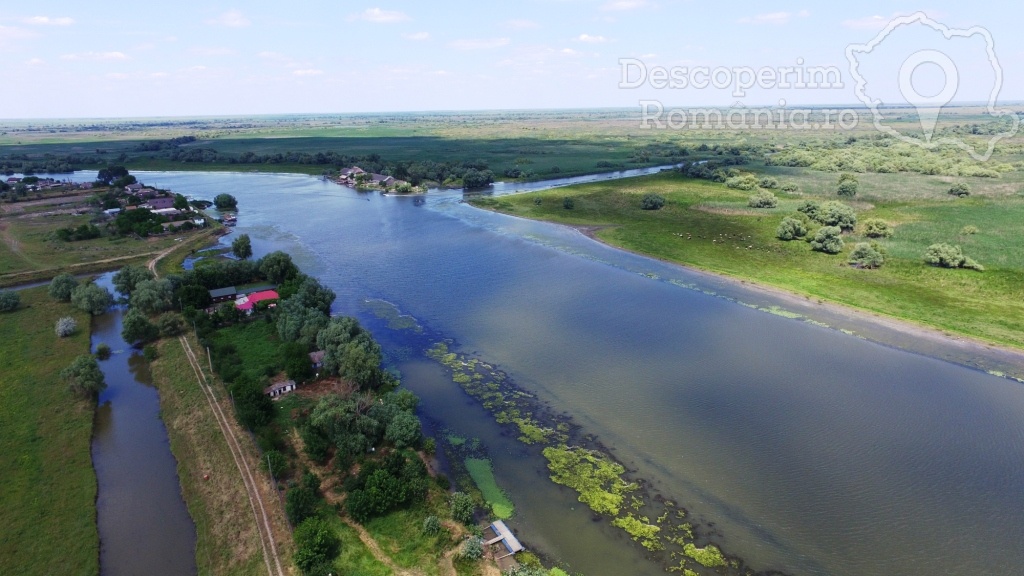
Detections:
[0, 0, 1024, 118]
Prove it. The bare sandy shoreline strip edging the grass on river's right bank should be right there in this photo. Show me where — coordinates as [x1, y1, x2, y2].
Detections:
[565, 220, 1024, 380]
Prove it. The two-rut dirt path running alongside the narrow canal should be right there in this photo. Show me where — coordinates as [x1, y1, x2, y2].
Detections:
[178, 336, 287, 576]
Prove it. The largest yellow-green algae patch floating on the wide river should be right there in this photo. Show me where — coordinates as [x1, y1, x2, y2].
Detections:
[544, 446, 638, 516]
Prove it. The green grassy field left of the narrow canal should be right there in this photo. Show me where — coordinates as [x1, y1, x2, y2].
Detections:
[0, 288, 99, 575]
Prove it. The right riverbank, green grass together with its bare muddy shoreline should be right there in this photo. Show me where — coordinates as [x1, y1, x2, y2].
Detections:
[470, 170, 1024, 378]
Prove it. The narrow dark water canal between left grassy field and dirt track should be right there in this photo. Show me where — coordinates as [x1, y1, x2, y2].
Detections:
[92, 274, 197, 576]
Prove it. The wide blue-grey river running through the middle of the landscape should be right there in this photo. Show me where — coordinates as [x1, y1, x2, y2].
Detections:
[99, 172, 1024, 576]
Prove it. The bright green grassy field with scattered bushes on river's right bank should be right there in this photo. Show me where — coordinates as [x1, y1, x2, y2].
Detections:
[473, 170, 1024, 347]
